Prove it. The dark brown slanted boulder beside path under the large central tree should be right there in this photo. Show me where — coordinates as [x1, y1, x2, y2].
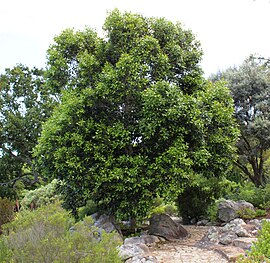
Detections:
[149, 214, 188, 241]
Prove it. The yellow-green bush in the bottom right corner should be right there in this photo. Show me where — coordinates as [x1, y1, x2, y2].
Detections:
[237, 221, 270, 263]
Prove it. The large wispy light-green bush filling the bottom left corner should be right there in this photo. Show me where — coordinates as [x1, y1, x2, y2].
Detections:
[0, 203, 121, 263]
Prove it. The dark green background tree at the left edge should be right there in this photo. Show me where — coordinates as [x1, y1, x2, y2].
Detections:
[0, 65, 56, 198]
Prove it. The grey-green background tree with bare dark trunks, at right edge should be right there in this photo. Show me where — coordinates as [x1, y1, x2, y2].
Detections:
[212, 56, 270, 186]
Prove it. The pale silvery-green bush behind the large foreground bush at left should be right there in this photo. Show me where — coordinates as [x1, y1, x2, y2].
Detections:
[20, 179, 60, 209]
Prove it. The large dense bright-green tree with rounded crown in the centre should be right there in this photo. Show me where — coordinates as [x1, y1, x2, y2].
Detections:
[35, 10, 237, 220]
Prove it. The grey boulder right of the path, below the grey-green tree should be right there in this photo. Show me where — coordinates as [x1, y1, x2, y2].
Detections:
[218, 200, 254, 222]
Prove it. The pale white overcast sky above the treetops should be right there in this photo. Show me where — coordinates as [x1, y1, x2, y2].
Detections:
[0, 0, 270, 75]
